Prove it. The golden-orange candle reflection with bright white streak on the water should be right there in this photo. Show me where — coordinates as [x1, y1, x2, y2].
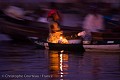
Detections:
[49, 51, 69, 79]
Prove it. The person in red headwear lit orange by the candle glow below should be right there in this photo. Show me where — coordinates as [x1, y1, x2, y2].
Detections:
[47, 3, 62, 43]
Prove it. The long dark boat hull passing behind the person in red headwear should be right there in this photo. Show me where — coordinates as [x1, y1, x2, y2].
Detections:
[0, 16, 80, 41]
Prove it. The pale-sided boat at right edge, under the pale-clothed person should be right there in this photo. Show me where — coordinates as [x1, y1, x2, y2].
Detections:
[83, 40, 120, 52]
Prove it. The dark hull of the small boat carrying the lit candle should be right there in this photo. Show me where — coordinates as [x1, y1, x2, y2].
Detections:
[34, 40, 85, 52]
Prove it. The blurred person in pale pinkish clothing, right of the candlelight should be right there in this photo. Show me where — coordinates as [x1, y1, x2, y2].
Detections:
[83, 9, 104, 41]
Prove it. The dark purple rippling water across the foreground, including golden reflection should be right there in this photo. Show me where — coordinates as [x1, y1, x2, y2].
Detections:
[0, 42, 120, 80]
